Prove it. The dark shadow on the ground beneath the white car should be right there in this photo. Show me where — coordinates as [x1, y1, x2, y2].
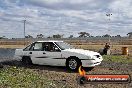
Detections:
[1, 60, 94, 73]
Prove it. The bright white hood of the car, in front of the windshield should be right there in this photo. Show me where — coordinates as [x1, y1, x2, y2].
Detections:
[64, 49, 100, 56]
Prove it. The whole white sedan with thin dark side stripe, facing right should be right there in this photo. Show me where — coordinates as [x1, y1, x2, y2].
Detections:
[15, 40, 103, 71]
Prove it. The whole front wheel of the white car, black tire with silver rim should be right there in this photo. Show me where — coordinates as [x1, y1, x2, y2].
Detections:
[66, 58, 81, 71]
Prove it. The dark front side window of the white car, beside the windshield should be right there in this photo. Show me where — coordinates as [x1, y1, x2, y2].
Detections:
[43, 42, 60, 52]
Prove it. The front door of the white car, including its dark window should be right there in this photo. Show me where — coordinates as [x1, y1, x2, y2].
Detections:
[43, 42, 65, 66]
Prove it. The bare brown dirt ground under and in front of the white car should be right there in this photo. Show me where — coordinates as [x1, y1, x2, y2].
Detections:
[2, 60, 132, 88]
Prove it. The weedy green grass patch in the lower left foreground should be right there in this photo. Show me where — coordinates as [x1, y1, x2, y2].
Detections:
[0, 66, 66, 88]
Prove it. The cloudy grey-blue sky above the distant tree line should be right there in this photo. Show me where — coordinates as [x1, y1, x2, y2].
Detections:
[0, 0, 132, 38]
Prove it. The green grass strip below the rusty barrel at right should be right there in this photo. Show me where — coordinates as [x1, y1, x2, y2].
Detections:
[103, 55, 132, 64]
